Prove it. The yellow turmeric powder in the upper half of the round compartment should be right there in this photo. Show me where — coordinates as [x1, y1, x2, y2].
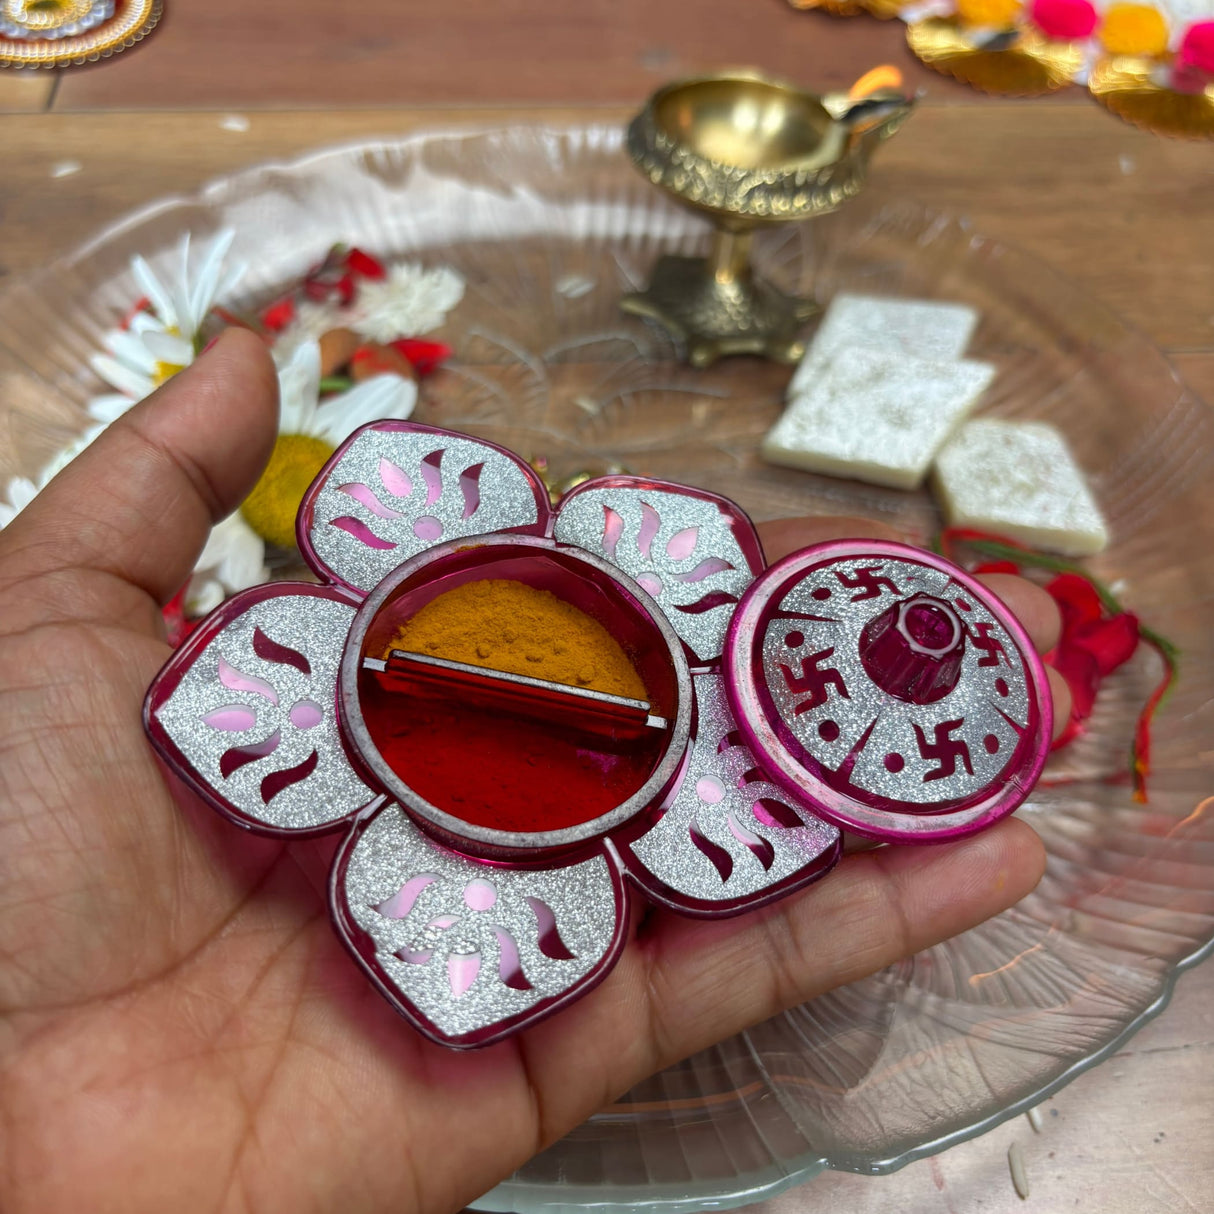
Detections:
[384, 579, 646, 699]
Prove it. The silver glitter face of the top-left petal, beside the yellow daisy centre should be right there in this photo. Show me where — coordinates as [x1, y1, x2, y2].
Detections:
[308, 427, 540, 592]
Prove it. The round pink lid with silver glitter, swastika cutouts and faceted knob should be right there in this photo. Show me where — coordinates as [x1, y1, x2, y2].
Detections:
[725, 540, 1053, 843]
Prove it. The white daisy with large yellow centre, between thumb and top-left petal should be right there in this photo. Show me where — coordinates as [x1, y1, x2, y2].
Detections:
[186, 341, 418, 602]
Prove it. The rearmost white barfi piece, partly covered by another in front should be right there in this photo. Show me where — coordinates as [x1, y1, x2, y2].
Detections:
[789, 295, 978, 395]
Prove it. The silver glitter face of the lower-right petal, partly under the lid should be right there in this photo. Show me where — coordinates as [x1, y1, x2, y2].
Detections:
[631, 675, 839, 902]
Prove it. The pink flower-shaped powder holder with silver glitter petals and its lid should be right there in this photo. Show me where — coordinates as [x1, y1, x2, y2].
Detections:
[144, 421, 1051, 1048]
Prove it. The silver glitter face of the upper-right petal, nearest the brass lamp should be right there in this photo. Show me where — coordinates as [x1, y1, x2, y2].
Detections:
[555, 482, 760, 663]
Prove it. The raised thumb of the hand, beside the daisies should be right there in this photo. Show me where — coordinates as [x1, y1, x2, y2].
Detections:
[0, 329, 278, 635]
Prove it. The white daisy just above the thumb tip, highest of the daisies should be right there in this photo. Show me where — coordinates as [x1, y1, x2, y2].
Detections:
[89, 228, 245, 422]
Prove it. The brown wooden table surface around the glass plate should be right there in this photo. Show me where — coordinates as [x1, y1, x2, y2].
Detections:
[0, 0, 1214, 1214]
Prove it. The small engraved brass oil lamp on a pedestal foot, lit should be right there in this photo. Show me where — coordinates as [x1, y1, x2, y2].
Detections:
[622, 69, 914, 367]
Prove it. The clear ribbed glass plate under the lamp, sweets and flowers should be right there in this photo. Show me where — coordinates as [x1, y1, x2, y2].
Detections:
[0, 127, 1214, 1212]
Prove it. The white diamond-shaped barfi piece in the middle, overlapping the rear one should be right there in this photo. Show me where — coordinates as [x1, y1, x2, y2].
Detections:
[761, 347, 994, 489]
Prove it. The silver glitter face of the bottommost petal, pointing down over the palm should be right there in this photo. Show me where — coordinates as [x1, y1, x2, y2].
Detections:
[341, 805, 623, 1039]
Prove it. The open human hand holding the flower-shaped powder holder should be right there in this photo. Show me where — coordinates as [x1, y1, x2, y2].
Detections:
[0, 330, 1067, 1214]
